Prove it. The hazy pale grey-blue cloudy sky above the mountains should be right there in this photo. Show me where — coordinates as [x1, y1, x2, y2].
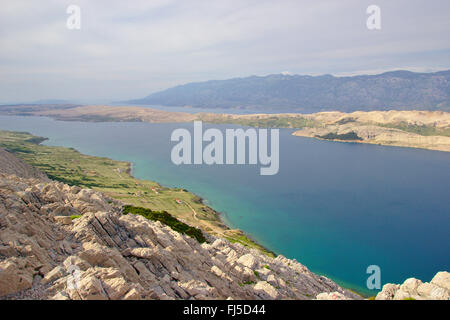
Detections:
[0, 0, 450, 103]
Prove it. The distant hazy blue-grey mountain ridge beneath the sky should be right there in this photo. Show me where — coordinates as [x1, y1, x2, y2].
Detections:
[127, 70, 450, 112]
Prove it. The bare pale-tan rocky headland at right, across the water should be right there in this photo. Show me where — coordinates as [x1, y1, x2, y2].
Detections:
[286, 110, 450, 152]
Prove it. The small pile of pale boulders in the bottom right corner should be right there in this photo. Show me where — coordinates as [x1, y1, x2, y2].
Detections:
[376, 271, 450, 300]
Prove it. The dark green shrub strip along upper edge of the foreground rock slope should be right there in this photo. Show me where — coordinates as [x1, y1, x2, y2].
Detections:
[122, 206, 206, 243]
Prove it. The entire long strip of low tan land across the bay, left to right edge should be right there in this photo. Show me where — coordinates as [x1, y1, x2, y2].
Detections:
[0, 104, 450, 152]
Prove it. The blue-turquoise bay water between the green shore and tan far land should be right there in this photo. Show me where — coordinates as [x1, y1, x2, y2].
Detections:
[0, 117, 450, 294]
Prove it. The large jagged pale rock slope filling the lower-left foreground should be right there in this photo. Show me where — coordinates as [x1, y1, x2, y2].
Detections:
[0, 174, 359, 300]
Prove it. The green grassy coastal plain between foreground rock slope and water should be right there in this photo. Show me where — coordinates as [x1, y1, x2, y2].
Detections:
[0, 131, 273, 256]
